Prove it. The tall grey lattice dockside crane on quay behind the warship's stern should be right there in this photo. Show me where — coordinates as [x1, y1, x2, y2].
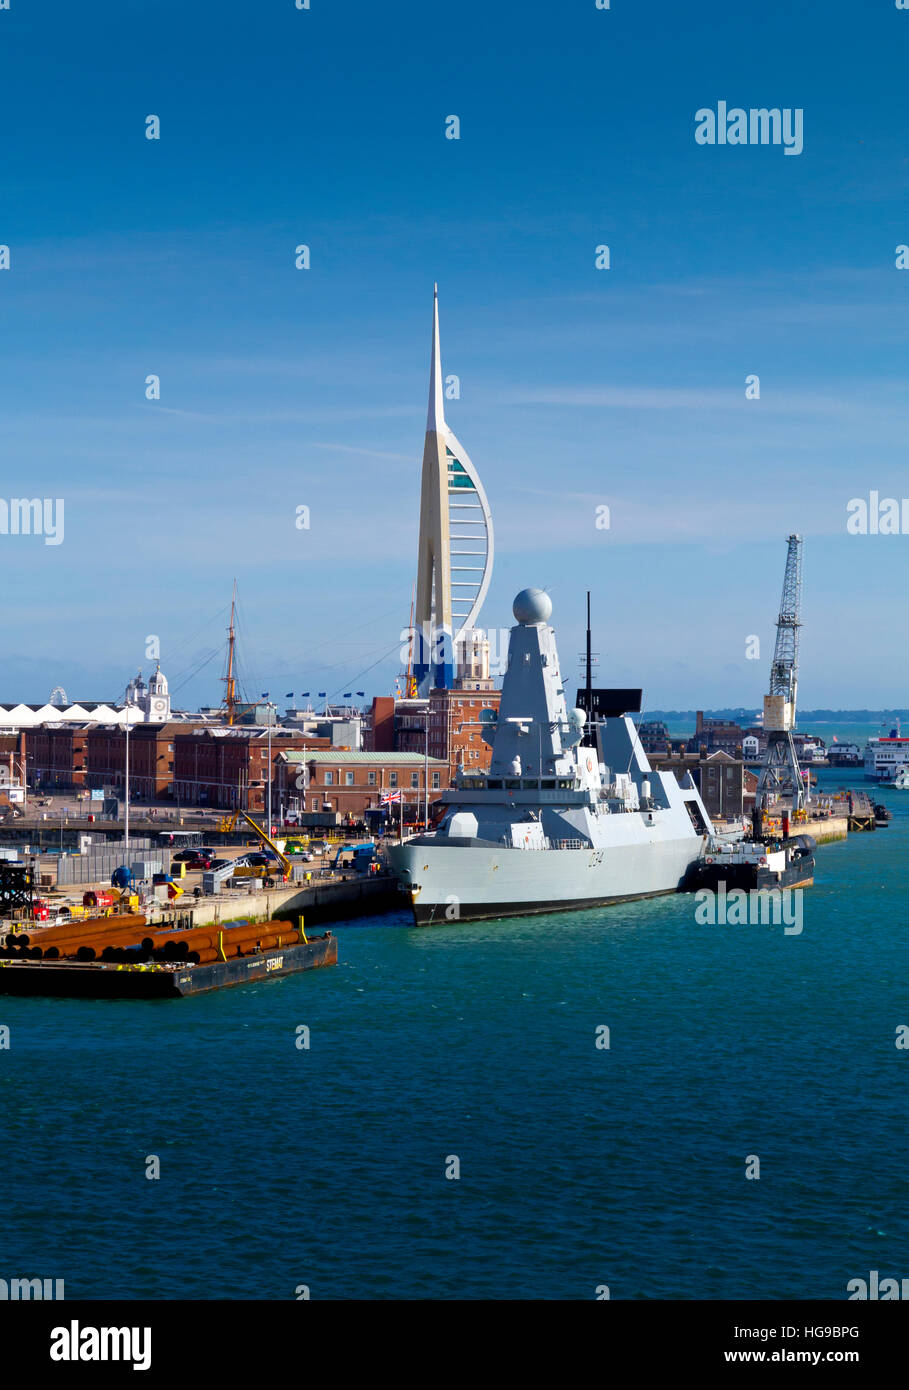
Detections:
[755, 535, 806, 813]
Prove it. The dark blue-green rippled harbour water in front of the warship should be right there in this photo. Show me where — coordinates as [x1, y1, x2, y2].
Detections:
[0, 773, 909, 1300]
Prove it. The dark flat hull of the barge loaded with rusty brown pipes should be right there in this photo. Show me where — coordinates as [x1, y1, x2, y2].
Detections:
[0, 934, 338, 999]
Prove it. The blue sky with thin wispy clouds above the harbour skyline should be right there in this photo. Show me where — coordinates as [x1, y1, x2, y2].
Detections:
[0, 0, 909, 708]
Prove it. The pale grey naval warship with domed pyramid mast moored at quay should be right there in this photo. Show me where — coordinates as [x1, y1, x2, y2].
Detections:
[388, 589, 713, 926]
